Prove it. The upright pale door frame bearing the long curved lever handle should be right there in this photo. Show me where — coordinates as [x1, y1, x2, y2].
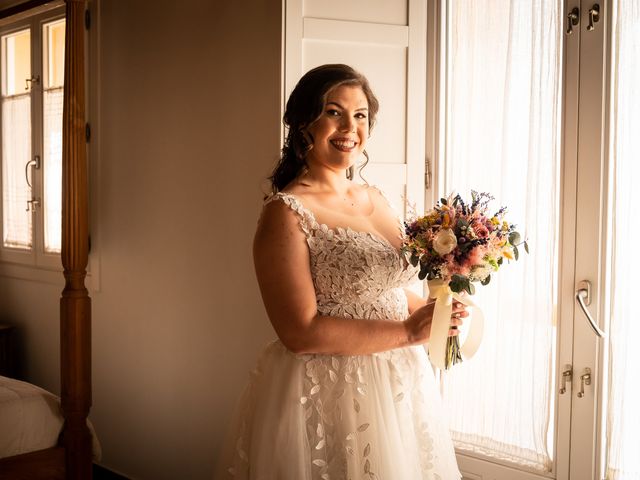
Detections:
[569, 0, 609, 480]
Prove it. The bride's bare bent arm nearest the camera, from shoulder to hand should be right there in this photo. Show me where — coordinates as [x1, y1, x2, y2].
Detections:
[253, 202, 442, 355]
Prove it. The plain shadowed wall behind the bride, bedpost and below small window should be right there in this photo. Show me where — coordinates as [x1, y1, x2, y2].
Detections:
[0, 0, 281, 480]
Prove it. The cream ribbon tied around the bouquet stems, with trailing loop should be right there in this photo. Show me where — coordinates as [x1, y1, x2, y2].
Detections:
[425, 280, 484, 370]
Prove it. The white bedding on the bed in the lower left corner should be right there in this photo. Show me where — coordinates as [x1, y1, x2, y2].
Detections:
[0, 376, 100, 458]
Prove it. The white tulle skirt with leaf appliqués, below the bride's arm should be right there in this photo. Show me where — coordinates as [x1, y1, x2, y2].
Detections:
[216, 341, 460, 480]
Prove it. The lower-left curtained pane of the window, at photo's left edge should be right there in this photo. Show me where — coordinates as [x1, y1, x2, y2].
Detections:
[2, 94, 32, 249]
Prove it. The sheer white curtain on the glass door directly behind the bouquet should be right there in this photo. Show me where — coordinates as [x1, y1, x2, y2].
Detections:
[442, 0, 563, 471]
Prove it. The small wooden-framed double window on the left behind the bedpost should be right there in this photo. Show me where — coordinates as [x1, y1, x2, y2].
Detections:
[0, 8, 65, 268]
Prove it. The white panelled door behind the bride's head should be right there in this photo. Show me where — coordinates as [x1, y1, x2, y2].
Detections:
[284, 0, 426, 214]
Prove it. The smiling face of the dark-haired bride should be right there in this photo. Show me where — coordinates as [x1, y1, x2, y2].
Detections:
[307, 85, 369, 170]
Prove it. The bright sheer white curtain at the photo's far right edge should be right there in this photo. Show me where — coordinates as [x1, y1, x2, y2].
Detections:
[606, 0, 640, 480]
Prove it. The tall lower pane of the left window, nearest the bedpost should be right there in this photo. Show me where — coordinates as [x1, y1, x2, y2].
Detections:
[43, 88, 63, 252]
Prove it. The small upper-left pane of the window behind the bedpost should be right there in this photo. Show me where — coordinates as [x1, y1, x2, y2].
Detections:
[2, 30, 31, 96]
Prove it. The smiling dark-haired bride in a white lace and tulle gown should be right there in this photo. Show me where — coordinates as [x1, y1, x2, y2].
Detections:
[219, 65, 467, 480]
